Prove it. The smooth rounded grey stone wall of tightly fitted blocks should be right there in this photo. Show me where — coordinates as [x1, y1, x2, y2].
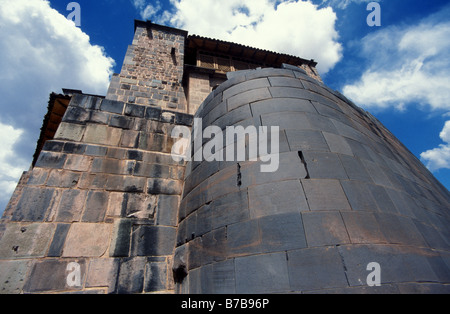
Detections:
[173, 66, 450, 293]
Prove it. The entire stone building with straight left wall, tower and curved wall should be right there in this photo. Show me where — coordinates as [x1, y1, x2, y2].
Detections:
[0, 21, 450, 294]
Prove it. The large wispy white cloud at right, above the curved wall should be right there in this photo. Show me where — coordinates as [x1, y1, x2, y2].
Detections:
[343, 19, 450, 110]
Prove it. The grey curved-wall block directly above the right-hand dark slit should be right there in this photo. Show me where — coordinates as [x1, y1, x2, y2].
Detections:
[286, 130, 330, 152]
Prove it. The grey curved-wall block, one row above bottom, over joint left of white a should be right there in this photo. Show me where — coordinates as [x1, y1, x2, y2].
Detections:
[259, 213, 307, 253]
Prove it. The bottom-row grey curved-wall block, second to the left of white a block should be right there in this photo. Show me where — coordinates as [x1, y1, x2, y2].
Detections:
[235, 252, 290, 293]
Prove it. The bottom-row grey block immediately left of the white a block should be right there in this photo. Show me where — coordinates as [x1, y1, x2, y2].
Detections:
[287, 247, 348, 291]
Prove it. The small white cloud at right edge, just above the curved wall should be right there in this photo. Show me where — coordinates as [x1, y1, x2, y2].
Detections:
[420, 121, 450, 171]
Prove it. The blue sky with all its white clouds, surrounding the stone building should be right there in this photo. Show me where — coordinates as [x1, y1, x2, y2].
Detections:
[0, 0, 450, 212]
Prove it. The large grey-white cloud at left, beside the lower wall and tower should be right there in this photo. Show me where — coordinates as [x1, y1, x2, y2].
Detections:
[0, 0, 114, 212]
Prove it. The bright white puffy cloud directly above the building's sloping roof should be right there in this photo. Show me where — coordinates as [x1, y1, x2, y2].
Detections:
[135, 0, 342, 74]
